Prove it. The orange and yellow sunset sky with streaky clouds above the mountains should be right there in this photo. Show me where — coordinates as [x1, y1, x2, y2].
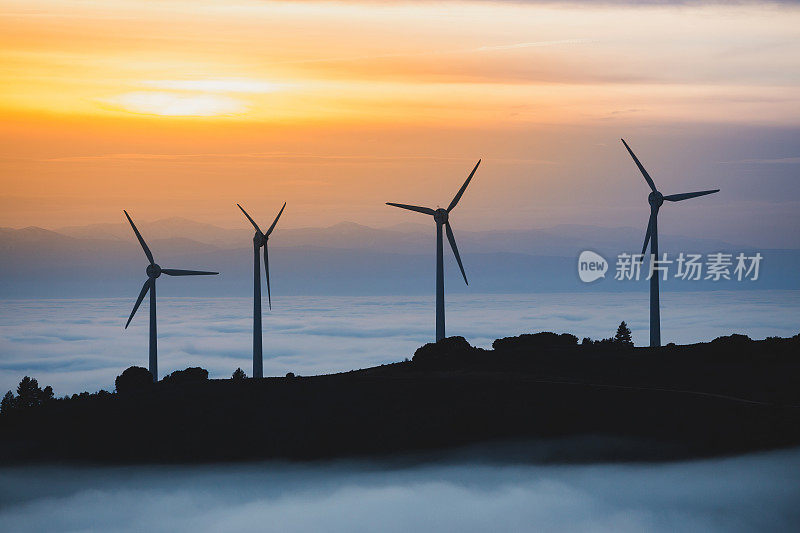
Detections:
[0, 0, 800, 247]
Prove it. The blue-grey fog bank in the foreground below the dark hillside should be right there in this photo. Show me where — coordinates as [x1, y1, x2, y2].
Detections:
[0, 449, 800, 533]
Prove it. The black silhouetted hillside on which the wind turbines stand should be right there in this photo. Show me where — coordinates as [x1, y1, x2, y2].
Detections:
[0, 337, 800, 463]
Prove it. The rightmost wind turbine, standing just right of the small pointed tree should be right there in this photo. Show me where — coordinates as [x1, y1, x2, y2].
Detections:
[620, 139, 719, 347]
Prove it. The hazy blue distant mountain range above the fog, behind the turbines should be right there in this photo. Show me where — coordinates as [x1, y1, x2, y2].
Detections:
[0, 218, 800, 298]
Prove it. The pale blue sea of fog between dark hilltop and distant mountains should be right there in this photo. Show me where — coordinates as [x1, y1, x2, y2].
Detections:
[0, 290, 800, 395]
